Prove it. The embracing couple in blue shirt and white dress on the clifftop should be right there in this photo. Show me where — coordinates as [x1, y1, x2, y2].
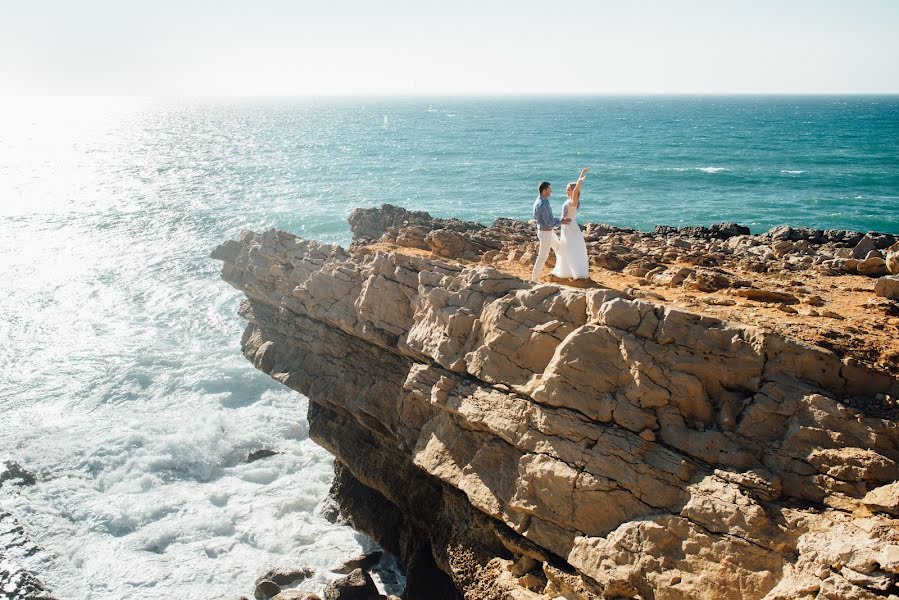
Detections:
[531, 167, 590, 282]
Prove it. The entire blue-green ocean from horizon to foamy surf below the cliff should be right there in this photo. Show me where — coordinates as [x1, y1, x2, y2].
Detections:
[0, 96, 899, 600]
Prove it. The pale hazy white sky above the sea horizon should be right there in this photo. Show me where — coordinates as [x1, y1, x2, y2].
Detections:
[0, 0, 899, 96]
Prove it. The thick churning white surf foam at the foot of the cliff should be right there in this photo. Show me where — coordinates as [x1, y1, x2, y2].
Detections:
[4, 390, 390, 598]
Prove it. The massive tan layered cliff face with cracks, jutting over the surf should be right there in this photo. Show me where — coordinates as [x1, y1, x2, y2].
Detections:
[213, 217, 899, 600]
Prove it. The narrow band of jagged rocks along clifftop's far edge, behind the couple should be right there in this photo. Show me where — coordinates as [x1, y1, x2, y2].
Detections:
[349, 204, 899, 289]
